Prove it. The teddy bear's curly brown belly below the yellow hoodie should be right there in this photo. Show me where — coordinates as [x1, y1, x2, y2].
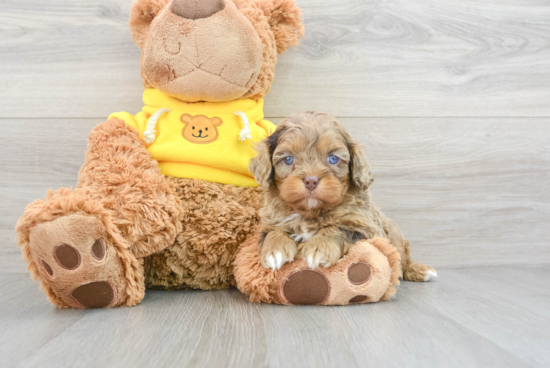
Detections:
[145, 179, 261, 290]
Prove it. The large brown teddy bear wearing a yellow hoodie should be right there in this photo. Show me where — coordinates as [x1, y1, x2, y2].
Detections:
[16, 0, 400, 308]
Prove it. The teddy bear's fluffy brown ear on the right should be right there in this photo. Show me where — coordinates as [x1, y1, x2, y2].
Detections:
[258, 0, 304, 54]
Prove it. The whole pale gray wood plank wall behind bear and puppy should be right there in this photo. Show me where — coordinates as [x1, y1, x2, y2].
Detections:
[0, 0, 550, 272]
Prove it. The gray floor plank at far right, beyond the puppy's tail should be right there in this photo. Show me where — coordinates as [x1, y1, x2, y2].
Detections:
[409, 266, 550, 367]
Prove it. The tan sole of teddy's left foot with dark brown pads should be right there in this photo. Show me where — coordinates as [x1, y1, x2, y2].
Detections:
[29, 214, 127, 309]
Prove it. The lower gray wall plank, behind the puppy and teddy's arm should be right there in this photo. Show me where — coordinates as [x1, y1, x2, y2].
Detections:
[0, 118, 550, 272]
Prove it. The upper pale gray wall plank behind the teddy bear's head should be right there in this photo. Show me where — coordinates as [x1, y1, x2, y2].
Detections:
[0, 0, 550, 118]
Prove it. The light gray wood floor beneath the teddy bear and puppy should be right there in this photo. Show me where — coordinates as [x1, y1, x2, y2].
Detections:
[0, 266, 550, 367]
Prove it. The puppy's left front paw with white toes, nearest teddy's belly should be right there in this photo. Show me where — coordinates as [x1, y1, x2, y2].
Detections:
[259, 230, 298, 270]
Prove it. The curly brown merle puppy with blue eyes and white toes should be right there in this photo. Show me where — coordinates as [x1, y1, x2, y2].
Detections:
[250, 112, 437, 281]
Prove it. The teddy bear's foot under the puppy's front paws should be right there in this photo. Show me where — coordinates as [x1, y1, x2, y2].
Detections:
[234, 238, 401, 305]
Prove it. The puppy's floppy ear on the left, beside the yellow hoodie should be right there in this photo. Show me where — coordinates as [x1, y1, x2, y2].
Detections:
[248, 129, 281, 189]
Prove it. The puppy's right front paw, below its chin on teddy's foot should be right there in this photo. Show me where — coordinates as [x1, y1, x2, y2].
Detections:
[301, 226, 346, 269]
